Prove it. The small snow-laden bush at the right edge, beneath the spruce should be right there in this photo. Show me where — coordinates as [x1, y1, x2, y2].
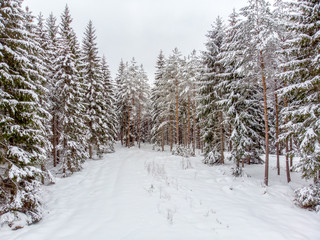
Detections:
[295, 182, 320, 212]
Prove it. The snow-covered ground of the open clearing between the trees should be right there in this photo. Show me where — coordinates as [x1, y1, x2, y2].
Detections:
[0, 145, 320, 240]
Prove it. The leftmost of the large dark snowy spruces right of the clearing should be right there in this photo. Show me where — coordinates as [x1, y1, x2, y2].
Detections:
[200, 17, 225, 164]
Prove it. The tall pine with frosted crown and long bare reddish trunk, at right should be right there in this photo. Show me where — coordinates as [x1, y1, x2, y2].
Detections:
[240, 0, 274, 185]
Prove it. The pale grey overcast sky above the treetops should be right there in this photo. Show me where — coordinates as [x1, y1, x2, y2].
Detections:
[24, 0, 251, 82]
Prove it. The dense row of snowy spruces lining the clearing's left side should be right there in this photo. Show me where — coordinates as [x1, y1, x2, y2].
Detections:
[0, 0, 118, 228]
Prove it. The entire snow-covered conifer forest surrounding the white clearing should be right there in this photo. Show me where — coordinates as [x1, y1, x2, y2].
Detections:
[0, 0, 320, 236]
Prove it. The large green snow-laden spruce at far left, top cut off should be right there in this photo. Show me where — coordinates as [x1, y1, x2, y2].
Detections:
[0, 0, 47, 228]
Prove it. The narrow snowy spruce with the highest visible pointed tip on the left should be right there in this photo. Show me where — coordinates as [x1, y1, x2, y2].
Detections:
[54, 6, 88, 176]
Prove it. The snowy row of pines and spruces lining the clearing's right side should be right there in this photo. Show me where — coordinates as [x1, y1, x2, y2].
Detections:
[151, 0, 320, 209]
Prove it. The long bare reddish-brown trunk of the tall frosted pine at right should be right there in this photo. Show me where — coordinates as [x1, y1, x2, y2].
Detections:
[260, 50, 269, 186]
